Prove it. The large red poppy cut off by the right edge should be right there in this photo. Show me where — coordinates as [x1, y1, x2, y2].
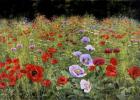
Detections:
[128, 66, 140, 79]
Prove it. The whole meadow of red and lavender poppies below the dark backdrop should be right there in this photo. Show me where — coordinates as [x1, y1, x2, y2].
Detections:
[0, 16, 140, 100]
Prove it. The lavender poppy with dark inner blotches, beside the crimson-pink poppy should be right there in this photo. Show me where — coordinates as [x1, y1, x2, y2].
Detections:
[80, 54, 93, 66]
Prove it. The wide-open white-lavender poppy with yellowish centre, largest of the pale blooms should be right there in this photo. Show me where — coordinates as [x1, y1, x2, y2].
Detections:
[69, 65, 86, 77]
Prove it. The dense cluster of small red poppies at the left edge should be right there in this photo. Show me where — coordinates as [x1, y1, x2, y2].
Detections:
[0, 58, 23, 89]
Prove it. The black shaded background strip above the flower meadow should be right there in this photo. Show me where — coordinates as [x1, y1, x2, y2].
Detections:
[0, 0, 140, 20]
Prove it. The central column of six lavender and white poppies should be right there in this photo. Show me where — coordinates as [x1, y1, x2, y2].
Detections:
[69, 37, 95, 93]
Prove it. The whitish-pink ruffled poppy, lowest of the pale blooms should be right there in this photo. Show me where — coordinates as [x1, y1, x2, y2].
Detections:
[80, 79, 91, 93]
